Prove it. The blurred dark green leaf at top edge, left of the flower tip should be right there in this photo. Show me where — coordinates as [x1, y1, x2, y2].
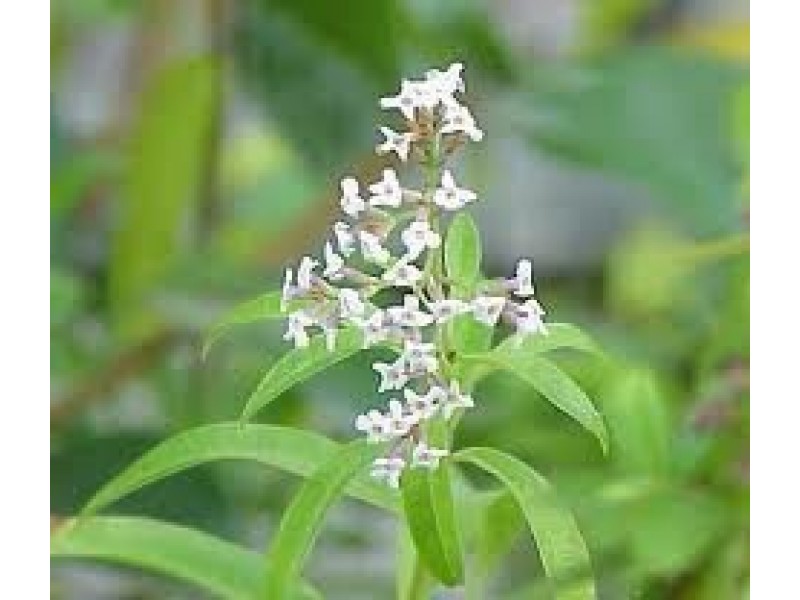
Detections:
[236, 0, 402, 170]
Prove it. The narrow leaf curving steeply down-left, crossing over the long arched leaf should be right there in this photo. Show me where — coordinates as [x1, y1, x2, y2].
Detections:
[263, 440, 385, 600]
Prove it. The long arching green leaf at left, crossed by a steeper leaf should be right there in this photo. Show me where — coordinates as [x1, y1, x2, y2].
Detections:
[82, 423, 399, 515]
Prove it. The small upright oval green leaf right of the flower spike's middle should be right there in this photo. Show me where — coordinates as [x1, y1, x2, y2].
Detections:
[444, 212, 481, 298]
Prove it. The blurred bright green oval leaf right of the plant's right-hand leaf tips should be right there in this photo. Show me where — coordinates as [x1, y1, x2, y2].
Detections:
[603, 369, 671, 477]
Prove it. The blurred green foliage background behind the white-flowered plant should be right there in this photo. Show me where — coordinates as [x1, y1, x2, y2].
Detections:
[50, 0, 749, 600]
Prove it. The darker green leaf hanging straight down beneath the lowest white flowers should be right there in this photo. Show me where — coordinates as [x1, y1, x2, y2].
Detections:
[401, 462, 464, 586]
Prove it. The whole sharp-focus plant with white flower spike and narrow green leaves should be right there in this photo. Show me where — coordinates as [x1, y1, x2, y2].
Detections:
[53, 63, 607, 600]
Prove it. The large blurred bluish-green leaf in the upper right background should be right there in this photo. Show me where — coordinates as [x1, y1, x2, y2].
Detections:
[520, 48, 745, 235]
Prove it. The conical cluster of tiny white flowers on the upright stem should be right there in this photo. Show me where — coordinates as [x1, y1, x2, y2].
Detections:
[282, 63, 546, 487]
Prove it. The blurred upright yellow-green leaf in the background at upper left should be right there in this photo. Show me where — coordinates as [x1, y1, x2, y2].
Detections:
[110, 58, 220, 333]
